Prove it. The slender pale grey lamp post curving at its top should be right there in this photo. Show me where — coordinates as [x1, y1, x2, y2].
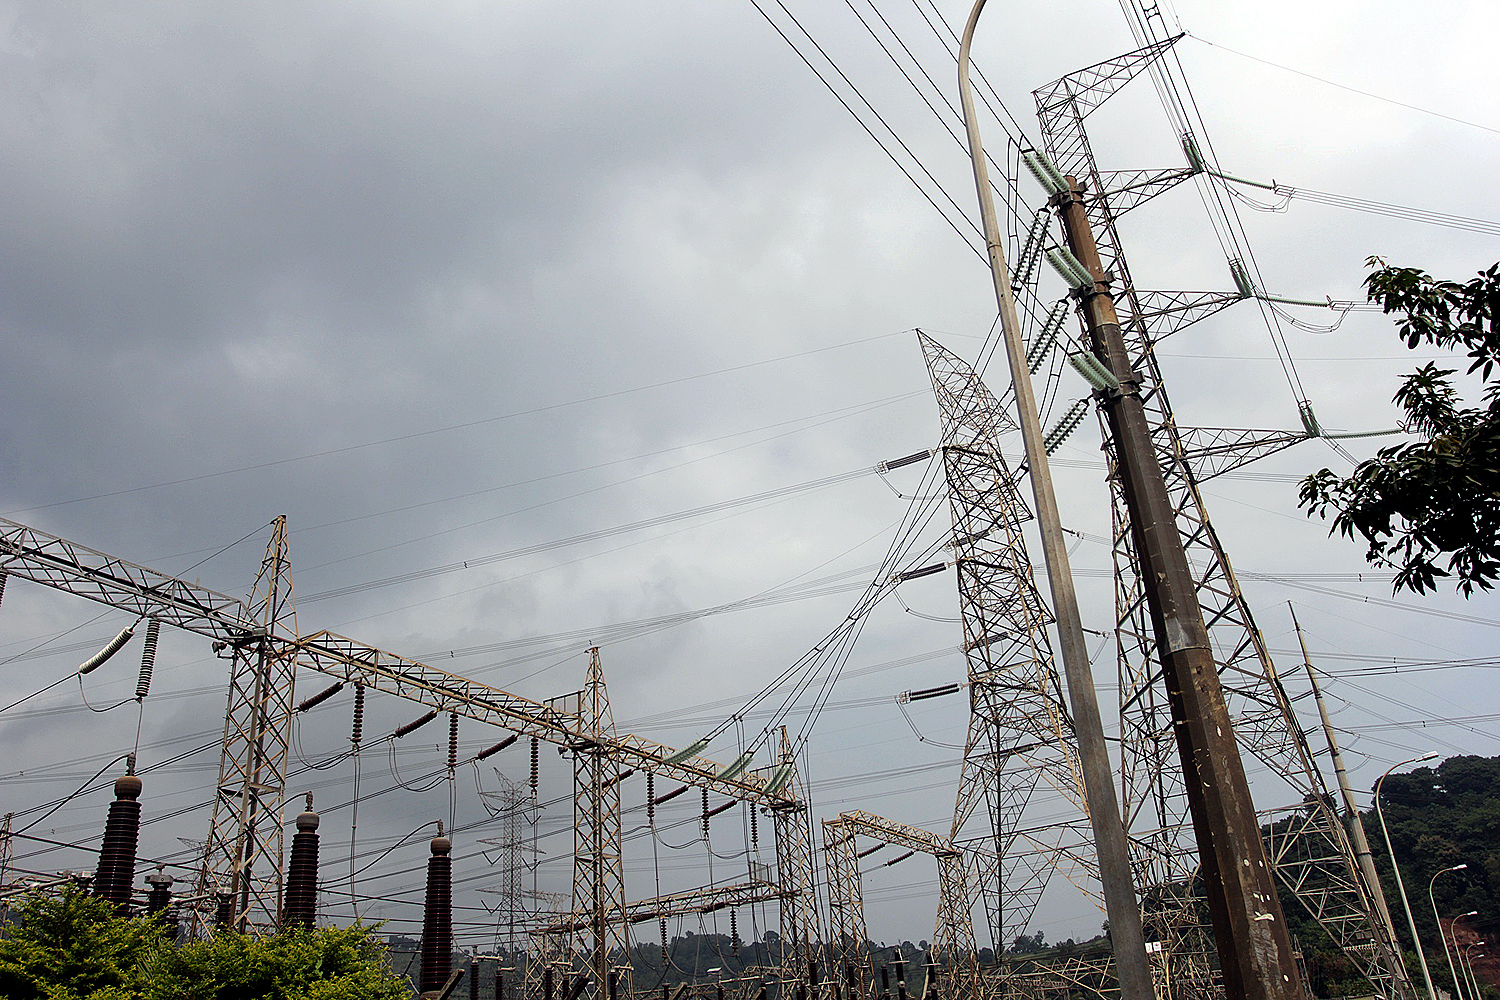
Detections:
[959, 7, 1155, 1000]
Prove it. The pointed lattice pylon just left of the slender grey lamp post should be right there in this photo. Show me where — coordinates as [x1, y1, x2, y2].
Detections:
[921, 334, 1088, 982]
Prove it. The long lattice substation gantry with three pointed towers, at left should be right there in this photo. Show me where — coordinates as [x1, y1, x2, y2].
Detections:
[0, 517, 822, 1000]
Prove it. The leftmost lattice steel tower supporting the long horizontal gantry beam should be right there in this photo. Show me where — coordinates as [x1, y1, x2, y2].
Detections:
[198, 516, 297, 933]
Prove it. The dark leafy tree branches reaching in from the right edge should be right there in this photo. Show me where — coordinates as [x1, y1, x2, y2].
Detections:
[1298, 258, 1500, 595]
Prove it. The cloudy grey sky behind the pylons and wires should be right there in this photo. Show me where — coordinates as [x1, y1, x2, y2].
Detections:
[0, 0, 1500, 949]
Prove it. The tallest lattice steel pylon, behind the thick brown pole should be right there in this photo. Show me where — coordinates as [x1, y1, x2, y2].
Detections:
[1035, 39, 1394, 997]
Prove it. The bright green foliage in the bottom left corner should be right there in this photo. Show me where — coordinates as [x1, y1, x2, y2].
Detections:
[0, 888, 411, 1000]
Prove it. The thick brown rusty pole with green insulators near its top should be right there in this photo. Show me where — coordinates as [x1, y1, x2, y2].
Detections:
[1052, 177, 1305, 1000]
